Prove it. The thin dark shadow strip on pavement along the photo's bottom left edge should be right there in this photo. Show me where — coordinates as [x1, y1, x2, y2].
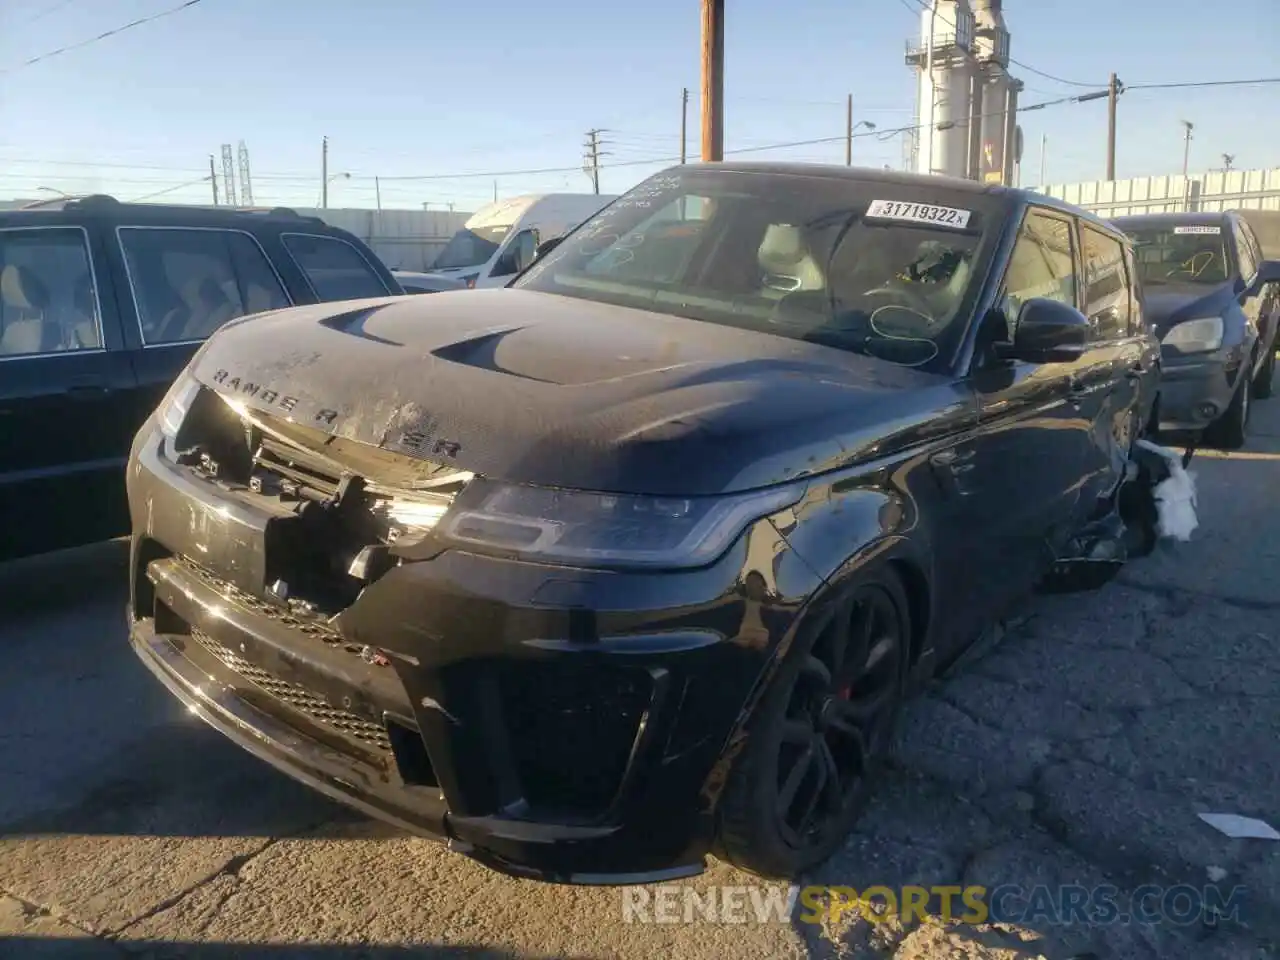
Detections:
[0, 937, 570, 960]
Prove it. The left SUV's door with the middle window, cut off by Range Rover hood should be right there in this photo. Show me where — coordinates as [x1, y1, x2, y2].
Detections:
[113, 225, 292, 430]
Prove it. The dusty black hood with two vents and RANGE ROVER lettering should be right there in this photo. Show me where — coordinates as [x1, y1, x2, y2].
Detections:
[192, 289, 965, 495]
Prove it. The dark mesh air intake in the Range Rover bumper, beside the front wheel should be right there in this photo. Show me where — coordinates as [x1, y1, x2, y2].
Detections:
[498, 659, 653, 815]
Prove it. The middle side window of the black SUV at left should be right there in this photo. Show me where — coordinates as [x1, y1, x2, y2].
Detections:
[119, 227, 289, 346]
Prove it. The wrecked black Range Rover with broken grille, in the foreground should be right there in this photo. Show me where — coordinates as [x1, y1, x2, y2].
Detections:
[128, 164, 1160, 883]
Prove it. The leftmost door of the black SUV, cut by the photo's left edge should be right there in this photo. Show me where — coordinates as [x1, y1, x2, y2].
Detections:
[0, 225, 134, 557]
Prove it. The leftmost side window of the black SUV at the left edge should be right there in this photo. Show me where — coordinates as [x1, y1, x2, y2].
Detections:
[0, 227, 102, 357]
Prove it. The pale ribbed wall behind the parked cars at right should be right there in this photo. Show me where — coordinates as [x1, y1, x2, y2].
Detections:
[1032, 168, 1280, 216]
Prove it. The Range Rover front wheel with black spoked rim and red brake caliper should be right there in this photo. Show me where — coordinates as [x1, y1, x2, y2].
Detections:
[716, 567, 911, 878]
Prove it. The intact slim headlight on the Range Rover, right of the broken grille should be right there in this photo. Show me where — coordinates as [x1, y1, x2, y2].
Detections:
[436, 479, 804, 567]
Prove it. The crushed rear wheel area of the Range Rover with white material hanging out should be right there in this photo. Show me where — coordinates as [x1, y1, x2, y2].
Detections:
[1039, 440, 1198, 594]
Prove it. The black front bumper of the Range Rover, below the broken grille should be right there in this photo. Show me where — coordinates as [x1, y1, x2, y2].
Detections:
[128, 427, 799, 883]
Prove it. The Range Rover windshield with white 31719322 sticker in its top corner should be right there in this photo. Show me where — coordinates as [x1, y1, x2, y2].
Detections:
[513, 170, 1001, 366]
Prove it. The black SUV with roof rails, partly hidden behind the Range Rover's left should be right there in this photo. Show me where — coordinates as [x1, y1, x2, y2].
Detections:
[0, 196, 403, 559]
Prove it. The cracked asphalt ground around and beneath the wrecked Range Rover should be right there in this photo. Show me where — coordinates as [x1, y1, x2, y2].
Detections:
[0, 401, 1280, 960]
